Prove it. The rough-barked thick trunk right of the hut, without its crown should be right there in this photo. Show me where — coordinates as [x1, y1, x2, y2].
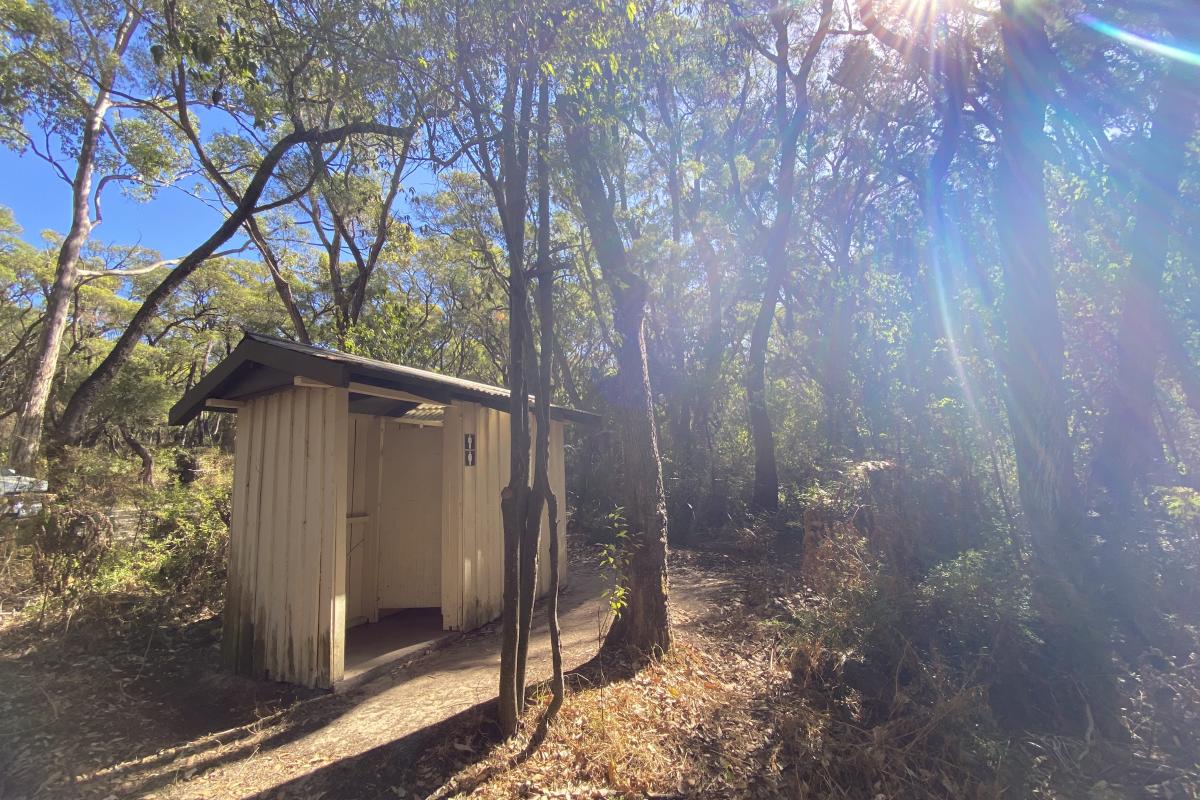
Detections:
[558, 97, 671, 655]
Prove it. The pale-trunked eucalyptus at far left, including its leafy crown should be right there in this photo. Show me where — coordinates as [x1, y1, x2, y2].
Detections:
[0, 0, 189, 473]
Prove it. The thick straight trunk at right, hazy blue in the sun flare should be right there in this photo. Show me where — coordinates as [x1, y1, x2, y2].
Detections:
[996, 0, 1120, 735]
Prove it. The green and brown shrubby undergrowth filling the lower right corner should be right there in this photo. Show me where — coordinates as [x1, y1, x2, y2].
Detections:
[775, 464, 1200, 798]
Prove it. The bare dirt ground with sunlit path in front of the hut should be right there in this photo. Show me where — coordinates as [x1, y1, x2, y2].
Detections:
[0, 554, 720, 800]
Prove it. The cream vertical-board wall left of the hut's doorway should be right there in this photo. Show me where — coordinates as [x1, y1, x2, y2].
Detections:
[223, 387, 347, 686]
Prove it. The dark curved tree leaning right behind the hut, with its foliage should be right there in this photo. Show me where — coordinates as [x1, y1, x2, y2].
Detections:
[55, 4, 432, 443]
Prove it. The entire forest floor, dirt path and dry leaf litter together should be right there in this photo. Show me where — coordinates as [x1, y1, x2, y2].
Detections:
[7, 542, 1198, 800]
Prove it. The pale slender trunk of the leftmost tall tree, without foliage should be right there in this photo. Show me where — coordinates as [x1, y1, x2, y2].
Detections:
[8, 10, 140, 475]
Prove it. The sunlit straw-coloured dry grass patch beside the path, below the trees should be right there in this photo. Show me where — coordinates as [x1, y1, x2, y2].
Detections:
[433, 556, 790, 798]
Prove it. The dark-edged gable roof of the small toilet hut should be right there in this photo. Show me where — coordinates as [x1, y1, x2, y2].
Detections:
[168, 331, 600, 425]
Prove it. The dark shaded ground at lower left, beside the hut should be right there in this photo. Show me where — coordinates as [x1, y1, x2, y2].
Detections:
[0, 597, 313, 798]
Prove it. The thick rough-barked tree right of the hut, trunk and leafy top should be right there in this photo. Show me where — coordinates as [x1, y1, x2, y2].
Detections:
[556, 2, 682, 655]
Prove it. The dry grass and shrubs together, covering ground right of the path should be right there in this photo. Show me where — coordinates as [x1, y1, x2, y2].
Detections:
[439, 462, 1200, 800]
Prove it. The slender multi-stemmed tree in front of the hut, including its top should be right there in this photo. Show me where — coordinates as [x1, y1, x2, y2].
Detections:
[420, 0, 554, 735]
